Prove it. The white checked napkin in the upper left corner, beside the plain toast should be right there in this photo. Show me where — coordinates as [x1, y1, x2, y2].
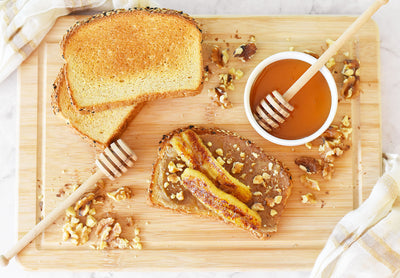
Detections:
[0, 0, 157, 83]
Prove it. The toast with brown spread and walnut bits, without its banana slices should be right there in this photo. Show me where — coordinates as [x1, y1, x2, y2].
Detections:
[148, 126, 292, 239]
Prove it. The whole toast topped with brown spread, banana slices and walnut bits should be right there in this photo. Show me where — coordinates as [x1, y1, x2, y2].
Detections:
[148, 126, 292, 239]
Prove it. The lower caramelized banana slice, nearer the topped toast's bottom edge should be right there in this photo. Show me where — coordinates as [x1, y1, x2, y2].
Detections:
[181, 168, 261, 230]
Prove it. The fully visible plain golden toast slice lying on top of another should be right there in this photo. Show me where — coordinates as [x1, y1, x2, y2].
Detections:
[61, 8, 203, 111]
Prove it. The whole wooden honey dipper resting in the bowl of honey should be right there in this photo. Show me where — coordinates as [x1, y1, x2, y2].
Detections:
[253, 0, 389, 131]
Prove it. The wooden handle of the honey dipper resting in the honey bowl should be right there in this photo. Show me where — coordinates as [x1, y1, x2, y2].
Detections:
[283, 0, 389, 102]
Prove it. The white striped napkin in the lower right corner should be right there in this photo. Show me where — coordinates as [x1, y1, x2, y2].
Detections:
[311, 155, 400, 277]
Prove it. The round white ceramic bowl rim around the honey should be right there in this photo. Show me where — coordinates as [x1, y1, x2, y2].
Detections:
[244, 51, 338, 146]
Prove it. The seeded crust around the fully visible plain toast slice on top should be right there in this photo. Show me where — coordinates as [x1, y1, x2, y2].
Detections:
[60, 7, 204, 113]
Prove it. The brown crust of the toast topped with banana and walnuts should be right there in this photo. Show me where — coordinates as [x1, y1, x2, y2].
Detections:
[147, 125, 292, 239]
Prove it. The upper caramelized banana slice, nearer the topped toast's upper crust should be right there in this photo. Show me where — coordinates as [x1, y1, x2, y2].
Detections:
[170, 130, 252, 203]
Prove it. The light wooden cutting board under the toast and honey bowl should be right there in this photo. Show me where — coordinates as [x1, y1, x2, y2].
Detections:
[18, 16, 381, 271]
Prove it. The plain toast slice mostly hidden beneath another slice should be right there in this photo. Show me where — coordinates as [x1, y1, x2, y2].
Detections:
[51, 68, 143, 149]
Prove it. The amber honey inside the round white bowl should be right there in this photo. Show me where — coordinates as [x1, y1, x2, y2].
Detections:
[250, 59, 331, 140]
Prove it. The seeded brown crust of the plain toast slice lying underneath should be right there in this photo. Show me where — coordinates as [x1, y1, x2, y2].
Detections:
[51, 65, 144, 151]
